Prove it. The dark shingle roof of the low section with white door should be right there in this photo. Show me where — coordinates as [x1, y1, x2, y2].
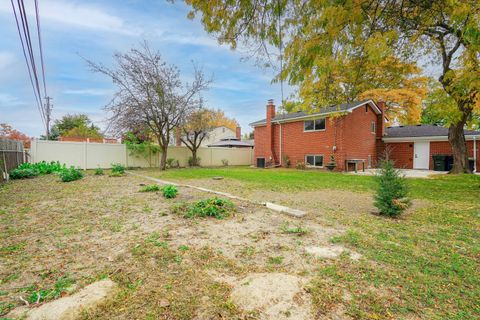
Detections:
[385, 124, 480, 138]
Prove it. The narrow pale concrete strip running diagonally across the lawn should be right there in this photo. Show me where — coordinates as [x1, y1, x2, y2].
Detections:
[125, 171, 307, 218]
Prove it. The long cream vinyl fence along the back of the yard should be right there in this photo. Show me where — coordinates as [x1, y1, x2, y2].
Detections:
[30, 140, 253, 169]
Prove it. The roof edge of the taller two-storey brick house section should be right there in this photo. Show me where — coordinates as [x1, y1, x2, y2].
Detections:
[250, 100, 381, 127]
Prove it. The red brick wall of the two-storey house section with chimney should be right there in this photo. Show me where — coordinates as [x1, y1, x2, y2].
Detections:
[254, 102, 378, 170]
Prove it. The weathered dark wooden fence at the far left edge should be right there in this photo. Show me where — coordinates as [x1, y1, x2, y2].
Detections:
[0, 138, 28, 183]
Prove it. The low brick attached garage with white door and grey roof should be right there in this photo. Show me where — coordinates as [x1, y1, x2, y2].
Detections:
[382, 125, 480, 172]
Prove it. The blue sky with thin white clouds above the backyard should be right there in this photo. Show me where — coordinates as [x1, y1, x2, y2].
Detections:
[0, 0, 288, 136]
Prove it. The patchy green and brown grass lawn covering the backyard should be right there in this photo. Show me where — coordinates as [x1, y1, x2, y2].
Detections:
[0, 167, 480, 319]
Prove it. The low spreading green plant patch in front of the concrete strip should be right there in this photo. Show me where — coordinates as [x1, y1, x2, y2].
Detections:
[172, 197, 235, 219]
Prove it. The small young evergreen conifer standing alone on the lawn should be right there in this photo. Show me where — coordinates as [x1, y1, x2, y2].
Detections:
[374, 160, 410, 217]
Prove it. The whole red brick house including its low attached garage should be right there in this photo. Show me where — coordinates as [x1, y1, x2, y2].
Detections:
[250, 100, 480, 170]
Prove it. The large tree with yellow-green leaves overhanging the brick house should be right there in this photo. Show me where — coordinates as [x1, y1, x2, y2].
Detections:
[186, 0, 480, 172]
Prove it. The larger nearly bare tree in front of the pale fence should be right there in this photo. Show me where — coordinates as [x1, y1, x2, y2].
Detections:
[87, 41, 211, 170]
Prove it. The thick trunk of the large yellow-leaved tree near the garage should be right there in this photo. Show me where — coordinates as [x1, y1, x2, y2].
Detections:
[448, 117, 471, 173]
